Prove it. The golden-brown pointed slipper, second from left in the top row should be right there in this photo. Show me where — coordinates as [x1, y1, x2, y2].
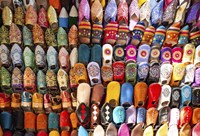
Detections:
[14, 6, 25, 27]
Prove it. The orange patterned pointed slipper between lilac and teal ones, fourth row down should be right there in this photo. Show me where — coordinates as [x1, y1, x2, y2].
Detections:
[23, 67, 36, 93]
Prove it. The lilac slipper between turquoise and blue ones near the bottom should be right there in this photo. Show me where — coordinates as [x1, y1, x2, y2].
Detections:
[125, 105, 136, 128]
